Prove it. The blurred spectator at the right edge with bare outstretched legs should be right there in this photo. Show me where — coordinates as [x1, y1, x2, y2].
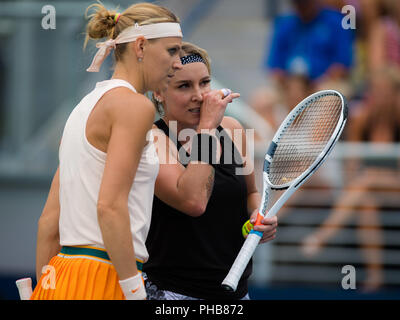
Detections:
[302, 66, 400, 291]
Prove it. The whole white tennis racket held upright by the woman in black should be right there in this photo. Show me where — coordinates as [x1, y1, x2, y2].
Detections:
[222, 90, 347, 291]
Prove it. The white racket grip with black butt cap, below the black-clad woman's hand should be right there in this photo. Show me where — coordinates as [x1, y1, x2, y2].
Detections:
[222, 230, 262, 291]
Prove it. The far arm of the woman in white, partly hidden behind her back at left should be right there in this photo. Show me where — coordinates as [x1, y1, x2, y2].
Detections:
[36, 168, 61, 281]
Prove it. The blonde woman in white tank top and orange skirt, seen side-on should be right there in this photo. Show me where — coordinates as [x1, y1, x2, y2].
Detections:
[31, 3, 182, 299]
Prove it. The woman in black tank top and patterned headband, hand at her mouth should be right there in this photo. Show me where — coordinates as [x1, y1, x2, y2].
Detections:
[144, 43, 277, 300]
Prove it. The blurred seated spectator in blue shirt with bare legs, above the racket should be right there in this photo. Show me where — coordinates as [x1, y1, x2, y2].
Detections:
[249, 0, 353, 146]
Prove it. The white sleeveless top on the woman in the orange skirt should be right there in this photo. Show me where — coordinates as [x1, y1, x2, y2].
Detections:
[59, 79, 159, 262]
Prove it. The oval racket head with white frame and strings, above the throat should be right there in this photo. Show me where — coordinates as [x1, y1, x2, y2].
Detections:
[263, 90, 348, 190]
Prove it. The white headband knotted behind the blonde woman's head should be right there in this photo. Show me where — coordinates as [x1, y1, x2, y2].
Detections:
[86, 22, 182, 72]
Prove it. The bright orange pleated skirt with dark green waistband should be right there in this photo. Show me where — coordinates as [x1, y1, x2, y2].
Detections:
[31, 246, 136, 300]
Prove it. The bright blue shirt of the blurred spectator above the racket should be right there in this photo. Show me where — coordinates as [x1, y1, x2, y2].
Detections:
[265, 0, 353, 88]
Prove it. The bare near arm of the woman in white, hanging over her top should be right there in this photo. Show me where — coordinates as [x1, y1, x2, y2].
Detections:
[97, 88, 155, 298]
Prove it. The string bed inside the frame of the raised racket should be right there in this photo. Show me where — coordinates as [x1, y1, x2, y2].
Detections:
[268, 95, 342, 185]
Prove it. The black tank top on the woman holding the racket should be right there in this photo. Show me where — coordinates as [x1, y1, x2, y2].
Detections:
[143, 119, 252, 299]
